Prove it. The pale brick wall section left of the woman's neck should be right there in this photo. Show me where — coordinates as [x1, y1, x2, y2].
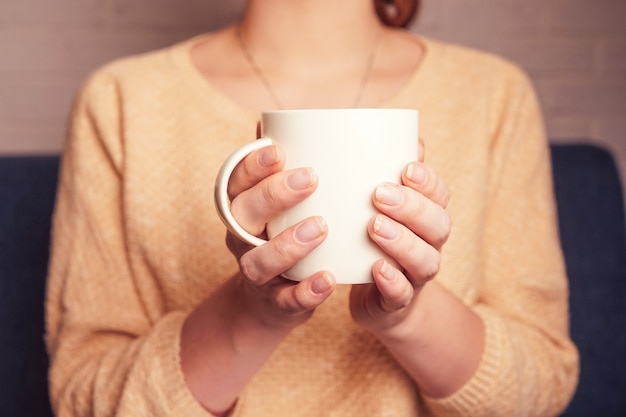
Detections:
[0, 0, 243, 153]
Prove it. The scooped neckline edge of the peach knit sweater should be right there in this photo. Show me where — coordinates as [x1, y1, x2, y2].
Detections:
[170, 31, 437, 120]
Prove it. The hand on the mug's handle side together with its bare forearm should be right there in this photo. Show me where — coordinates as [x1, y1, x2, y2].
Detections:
[180, 142, 335, 415]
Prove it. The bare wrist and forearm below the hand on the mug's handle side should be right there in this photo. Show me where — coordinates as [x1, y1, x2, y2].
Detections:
[180, 277, 289, 413]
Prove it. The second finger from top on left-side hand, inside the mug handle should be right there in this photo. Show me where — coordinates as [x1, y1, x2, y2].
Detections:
[230, 168, 317, 235]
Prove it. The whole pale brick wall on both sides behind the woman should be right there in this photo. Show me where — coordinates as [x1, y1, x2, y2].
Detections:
[0, 0, 626, 184]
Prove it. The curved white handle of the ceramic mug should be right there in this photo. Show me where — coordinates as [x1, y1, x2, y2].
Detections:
[214, 137, 274, 246]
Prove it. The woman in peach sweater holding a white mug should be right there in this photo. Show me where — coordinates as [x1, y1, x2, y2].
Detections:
[47, 0, 578, 416]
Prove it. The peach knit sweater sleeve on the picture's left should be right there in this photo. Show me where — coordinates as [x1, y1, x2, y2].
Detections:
[46, 66, 214, 417]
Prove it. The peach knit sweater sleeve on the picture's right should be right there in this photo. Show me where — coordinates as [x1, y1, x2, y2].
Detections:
[425, 63, 578, 417]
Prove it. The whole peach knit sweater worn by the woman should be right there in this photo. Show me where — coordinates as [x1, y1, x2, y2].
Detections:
[46, 33, 578, 417]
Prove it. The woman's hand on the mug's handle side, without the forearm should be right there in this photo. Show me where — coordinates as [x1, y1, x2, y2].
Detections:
[226, 146, 335, 327]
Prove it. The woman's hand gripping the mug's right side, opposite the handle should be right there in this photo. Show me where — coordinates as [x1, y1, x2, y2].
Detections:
[350, 144, 450, 334]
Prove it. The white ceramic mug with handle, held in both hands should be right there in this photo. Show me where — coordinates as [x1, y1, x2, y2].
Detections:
[215, 109, 418, 284]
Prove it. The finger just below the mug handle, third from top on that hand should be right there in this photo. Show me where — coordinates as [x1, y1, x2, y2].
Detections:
[239, 217, 328, 285]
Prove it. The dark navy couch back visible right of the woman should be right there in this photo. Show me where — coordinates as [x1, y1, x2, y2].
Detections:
[552, 145, 626, 417]
